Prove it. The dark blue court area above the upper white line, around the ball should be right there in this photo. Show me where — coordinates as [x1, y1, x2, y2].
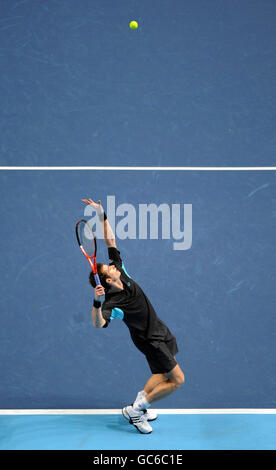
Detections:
[0, 0, 276, 166]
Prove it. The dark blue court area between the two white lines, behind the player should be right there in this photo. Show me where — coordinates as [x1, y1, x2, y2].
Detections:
[0, 171, 276, 408]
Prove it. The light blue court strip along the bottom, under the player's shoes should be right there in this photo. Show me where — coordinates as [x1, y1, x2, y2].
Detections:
[0, 410, 276, 450]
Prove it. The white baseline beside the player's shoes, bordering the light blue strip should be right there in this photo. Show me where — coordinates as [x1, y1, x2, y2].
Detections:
[0, 408, 276, 416]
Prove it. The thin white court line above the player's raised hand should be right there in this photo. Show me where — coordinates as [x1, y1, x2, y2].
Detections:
[0, 166, 276, 171]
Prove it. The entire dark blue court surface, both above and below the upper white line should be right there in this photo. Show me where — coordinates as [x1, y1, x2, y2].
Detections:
[0, 0, 276, 409]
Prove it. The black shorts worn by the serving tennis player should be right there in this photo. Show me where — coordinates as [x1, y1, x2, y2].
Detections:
[133, 335, 178, 374]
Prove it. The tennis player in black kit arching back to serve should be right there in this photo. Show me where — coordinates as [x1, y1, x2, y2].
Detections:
[83, 199, 185, 434]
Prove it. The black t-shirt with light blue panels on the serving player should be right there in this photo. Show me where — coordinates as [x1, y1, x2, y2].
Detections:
[102, 248, 171, 342]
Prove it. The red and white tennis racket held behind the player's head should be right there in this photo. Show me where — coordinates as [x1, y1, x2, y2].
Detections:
[76, 219, 101, 285]
